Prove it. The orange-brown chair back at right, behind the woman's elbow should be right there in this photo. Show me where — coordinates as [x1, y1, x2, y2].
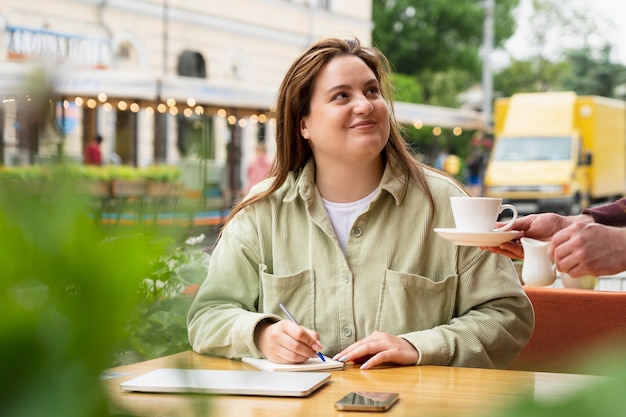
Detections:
[509, 287, 626, 372]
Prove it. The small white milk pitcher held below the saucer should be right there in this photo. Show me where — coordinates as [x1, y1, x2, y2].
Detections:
[521, 237, 556, 287]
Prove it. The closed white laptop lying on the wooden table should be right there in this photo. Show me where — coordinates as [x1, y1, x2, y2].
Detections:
[120, 368, 331, 397]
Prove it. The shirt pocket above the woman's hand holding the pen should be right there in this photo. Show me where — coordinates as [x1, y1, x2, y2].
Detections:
[260, 268, 315, 329]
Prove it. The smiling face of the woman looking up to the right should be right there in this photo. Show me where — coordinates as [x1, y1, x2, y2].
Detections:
[300, 55, 390, 166]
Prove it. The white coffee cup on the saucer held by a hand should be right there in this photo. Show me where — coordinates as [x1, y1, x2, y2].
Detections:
[450, 197, 517, 233]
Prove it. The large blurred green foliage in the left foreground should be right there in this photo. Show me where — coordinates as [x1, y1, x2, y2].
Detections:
[0, 177, 158, 417]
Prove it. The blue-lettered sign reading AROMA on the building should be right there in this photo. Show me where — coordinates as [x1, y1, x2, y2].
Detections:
[7, 26, 111, 68]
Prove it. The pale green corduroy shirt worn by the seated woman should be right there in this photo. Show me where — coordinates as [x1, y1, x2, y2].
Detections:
[187, 160, 534, 368]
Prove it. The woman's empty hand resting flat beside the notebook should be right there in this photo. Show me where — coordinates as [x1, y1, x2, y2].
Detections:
[333, 332, 419, 369]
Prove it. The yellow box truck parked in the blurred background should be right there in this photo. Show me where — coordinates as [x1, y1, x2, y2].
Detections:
[483, 92, 626, 214]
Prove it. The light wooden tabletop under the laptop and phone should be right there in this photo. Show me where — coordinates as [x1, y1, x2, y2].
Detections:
[103, 352, 599, 417]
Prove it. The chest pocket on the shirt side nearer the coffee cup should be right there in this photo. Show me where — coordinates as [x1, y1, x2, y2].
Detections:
[376, 270, 458, 335]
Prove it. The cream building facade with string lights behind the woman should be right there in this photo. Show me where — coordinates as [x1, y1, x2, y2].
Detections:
[0, 0, 372, 188]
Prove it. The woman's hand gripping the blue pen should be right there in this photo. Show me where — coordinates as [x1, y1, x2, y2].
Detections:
[254, 320, 322, 363]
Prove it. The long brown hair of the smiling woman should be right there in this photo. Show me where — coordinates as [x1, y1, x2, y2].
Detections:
[224, 38, 434, 234]
